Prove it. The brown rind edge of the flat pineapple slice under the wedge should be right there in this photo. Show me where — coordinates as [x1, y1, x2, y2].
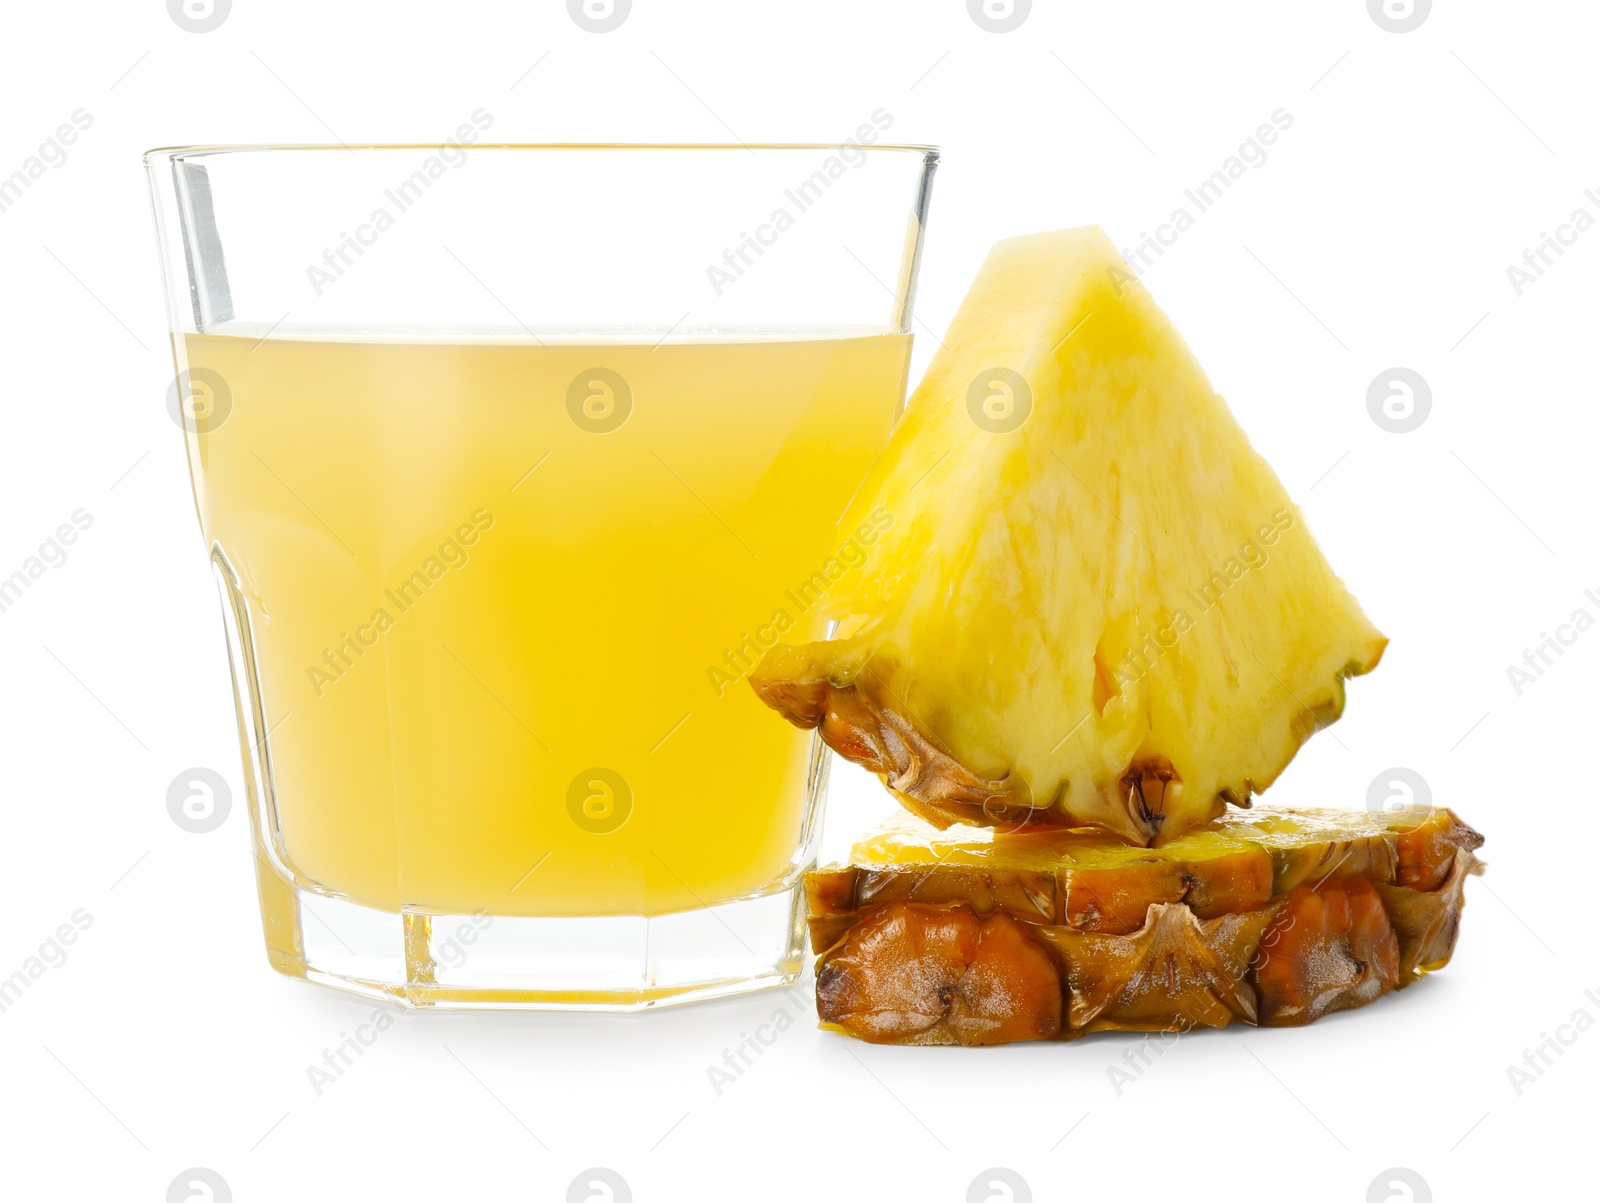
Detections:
[806, 811, 1483, 1045]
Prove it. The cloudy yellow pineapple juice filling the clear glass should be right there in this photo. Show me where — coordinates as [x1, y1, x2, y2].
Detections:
[178, 334, 910, 917]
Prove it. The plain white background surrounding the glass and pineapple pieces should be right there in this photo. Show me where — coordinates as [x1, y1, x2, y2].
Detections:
[0, 0, 1600, 1203]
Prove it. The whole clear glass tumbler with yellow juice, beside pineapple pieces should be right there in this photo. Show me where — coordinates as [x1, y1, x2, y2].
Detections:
[146, 140, 938, 1008]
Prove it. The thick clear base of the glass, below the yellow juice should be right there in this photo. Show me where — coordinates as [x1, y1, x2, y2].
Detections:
[258, 862, 805, 1011]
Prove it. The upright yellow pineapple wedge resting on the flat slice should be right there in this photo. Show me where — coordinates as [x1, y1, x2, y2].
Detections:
[750, 227, 1386, 845]
